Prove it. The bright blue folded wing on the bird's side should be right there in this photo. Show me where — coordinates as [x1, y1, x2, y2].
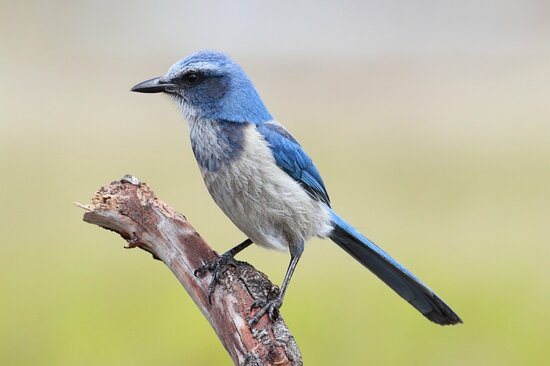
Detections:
[256, 121, 330, 206]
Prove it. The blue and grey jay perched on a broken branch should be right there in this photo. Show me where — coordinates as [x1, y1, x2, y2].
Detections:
[131, 50, 462, 326]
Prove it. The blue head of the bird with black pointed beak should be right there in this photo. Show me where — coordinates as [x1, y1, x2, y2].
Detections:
[132, 51, 272, 124]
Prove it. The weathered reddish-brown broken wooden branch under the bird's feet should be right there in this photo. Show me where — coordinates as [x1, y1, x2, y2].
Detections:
[77, 176, 303, 366]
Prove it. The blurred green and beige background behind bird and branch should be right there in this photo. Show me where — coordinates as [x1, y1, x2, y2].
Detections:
[0, 0, 550, 365]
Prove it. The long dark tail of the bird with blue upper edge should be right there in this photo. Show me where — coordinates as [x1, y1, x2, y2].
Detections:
[330, 212, 462, 325]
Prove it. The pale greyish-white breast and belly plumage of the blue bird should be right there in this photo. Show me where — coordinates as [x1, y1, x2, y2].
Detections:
[192, 121, 332, 250]
